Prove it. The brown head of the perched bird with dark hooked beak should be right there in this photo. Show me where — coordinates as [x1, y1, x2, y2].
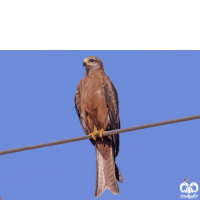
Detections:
[83, 56, 103, 73]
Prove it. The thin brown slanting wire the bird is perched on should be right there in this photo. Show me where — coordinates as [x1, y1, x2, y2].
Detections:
[0, 115, 200, 155]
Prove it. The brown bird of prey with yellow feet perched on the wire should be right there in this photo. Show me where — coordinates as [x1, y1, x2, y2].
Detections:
[75, 56, 123, 197]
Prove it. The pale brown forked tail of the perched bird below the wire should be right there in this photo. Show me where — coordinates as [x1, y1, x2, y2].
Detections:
[94, 147, 119, 197]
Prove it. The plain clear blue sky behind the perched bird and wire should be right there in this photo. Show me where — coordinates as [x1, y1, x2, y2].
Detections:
[0, 51, 200, 200]
